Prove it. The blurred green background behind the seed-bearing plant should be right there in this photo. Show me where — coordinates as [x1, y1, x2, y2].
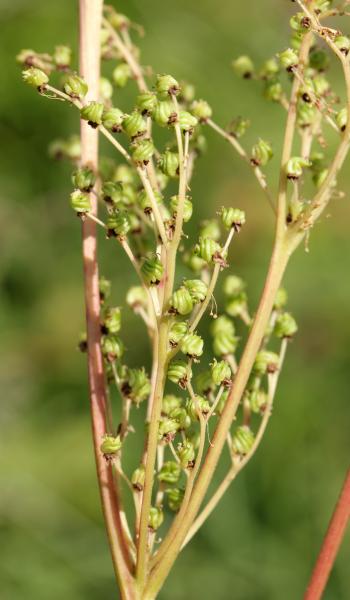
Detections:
[0, 0, 350, 600]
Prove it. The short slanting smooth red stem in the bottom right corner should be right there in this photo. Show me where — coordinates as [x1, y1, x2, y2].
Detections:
[304, 470, 350, 600]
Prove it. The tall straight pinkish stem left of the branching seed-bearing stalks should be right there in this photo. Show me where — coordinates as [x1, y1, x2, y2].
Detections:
[79, 0, 132, 598]
